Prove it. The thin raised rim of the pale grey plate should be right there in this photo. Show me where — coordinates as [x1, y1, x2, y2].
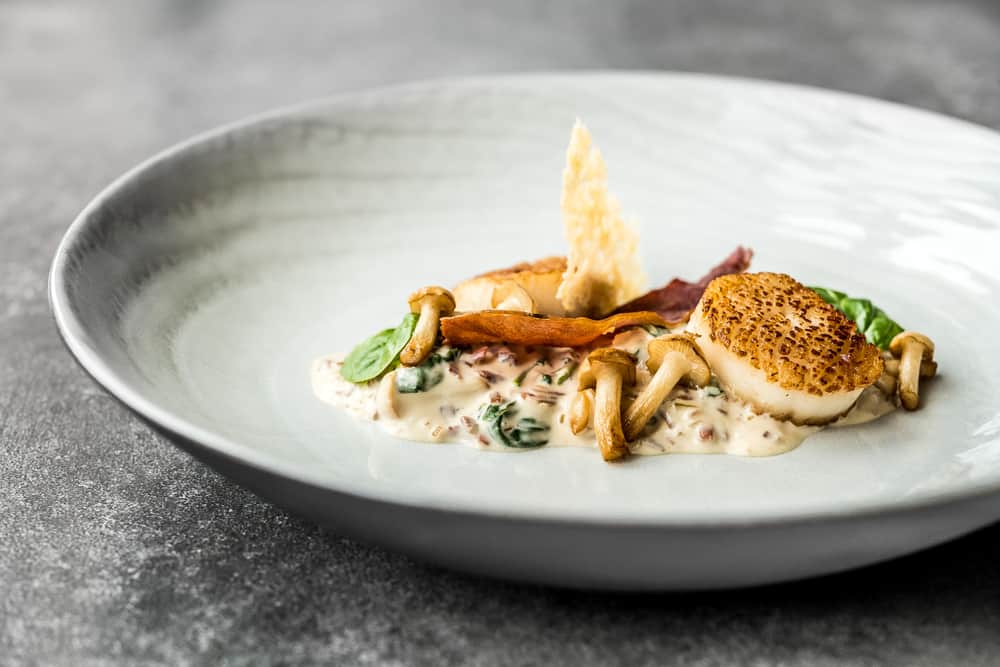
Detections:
[47, 69, 1000, 530]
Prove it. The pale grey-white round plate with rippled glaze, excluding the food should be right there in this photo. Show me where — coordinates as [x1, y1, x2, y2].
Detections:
[51, 74, 1000, 589]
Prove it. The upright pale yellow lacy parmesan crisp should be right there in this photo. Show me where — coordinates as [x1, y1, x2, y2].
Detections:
[556, 120, 646, 317]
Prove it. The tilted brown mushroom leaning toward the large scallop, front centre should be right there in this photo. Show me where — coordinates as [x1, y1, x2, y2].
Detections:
[624, 334, 712, 442]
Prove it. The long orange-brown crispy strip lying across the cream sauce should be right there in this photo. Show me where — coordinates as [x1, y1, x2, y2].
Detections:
[441, 310, 666, 347]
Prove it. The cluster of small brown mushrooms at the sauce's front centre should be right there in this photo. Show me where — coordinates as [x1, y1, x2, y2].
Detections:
[569, 334, 712, 461]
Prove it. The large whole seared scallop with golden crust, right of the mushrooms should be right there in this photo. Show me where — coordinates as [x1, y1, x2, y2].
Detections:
[689, 273, 884, 424]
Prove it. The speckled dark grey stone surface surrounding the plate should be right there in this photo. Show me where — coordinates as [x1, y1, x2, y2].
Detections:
[0, 0, 1000, 665]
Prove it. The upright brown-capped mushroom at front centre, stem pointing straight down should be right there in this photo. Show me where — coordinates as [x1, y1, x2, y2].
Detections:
[579, 347, 635, 461]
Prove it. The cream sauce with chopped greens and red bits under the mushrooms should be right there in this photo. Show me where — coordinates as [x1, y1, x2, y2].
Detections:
[312, 329, 896, 456]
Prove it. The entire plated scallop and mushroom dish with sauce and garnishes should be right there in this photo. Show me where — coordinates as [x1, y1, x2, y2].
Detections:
[312, 122, 937, 461]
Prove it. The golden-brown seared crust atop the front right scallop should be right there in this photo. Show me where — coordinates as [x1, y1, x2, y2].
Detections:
[698, 273, 884, 396]
